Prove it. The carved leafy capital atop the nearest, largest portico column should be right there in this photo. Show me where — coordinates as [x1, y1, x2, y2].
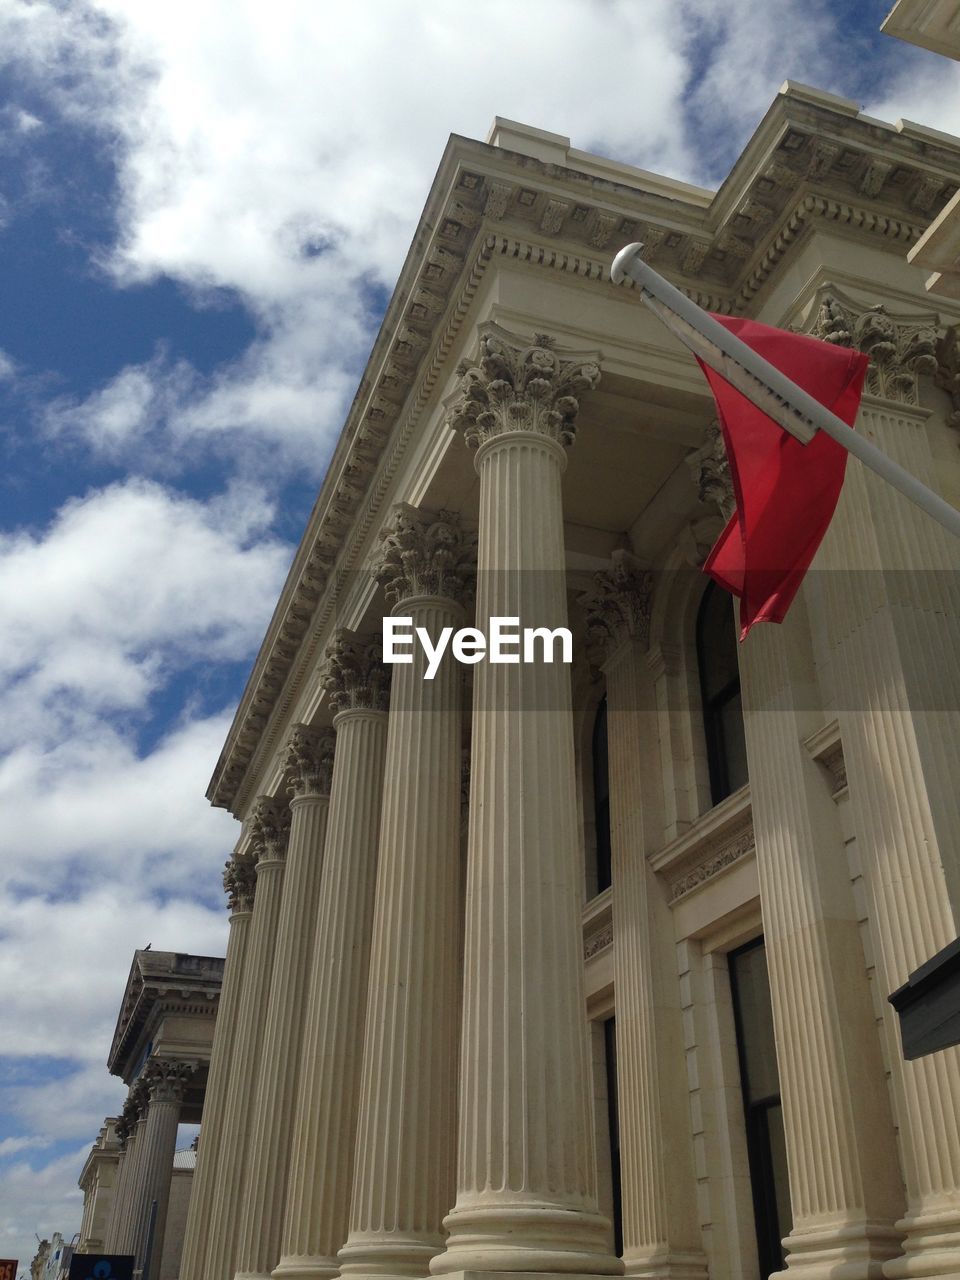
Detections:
[447, 324, 600, 448]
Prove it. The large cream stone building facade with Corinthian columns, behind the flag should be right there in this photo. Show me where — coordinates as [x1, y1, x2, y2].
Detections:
[180, 84, 960, 1280]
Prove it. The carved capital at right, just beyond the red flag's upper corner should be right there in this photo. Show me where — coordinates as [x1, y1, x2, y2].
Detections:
[812, 284, 938, 404]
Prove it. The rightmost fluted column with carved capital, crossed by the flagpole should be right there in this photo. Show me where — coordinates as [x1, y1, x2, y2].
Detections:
[808, 297, 960, 1277]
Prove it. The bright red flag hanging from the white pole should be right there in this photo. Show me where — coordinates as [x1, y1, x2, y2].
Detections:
[700, 316, 869, 640]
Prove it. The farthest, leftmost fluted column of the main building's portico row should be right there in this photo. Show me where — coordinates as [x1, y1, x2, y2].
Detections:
[180, 854, 256, 1280]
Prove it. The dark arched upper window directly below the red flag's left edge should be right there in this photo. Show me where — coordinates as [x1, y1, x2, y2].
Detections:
[696, 582, 746, 804]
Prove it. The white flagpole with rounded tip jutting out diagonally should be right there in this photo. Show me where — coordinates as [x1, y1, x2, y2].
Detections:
[611, 243, 960, 538]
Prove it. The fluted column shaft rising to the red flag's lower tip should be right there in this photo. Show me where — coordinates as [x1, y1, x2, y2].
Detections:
[731, 602, 902, 1280]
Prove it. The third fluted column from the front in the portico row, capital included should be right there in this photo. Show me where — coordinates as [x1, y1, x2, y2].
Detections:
[274, 632, 389, 1280]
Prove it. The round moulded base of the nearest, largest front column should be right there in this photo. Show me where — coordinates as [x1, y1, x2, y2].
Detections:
[430, 1204, 623, 1276]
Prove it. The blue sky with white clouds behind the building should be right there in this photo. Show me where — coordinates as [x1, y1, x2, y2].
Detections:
[0, 0, 960, 1267]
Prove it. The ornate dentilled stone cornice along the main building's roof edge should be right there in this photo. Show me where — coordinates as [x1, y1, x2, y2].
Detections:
[207, 86, 960, 815]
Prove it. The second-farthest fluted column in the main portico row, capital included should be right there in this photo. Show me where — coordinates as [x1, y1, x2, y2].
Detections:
[200, 796, 291, 1280]
